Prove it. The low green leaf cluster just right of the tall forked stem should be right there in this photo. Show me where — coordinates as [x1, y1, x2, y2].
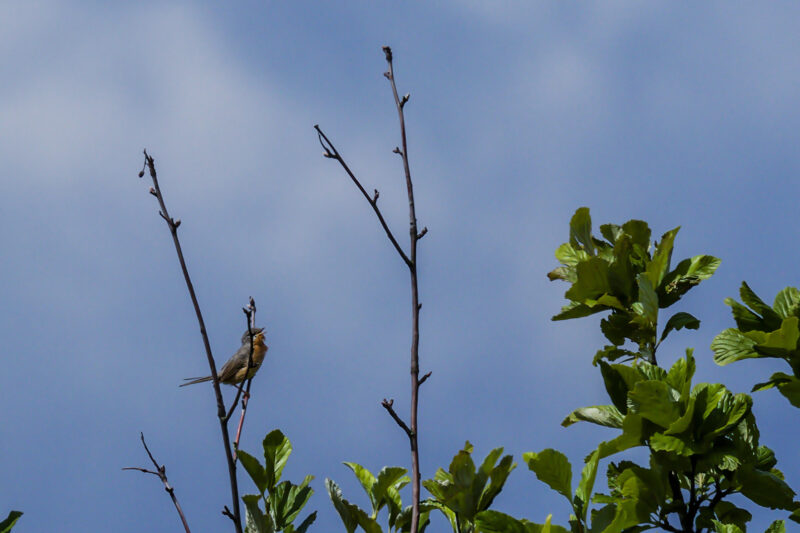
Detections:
[422, 442, 517, 533]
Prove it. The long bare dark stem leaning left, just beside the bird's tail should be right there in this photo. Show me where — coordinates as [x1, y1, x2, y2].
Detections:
[139, 150, 242, 533]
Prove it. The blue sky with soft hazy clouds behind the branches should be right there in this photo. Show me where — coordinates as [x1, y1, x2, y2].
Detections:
[0, 0, 800, 532]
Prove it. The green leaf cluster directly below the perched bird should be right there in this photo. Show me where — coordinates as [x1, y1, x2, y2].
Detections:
[236, 429, 317, 533]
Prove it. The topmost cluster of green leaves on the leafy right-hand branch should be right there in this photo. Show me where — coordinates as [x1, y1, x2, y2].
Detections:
[548, 207, 720, 364]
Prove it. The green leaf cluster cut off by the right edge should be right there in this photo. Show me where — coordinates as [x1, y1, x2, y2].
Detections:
[711, 282, 800, 407]
